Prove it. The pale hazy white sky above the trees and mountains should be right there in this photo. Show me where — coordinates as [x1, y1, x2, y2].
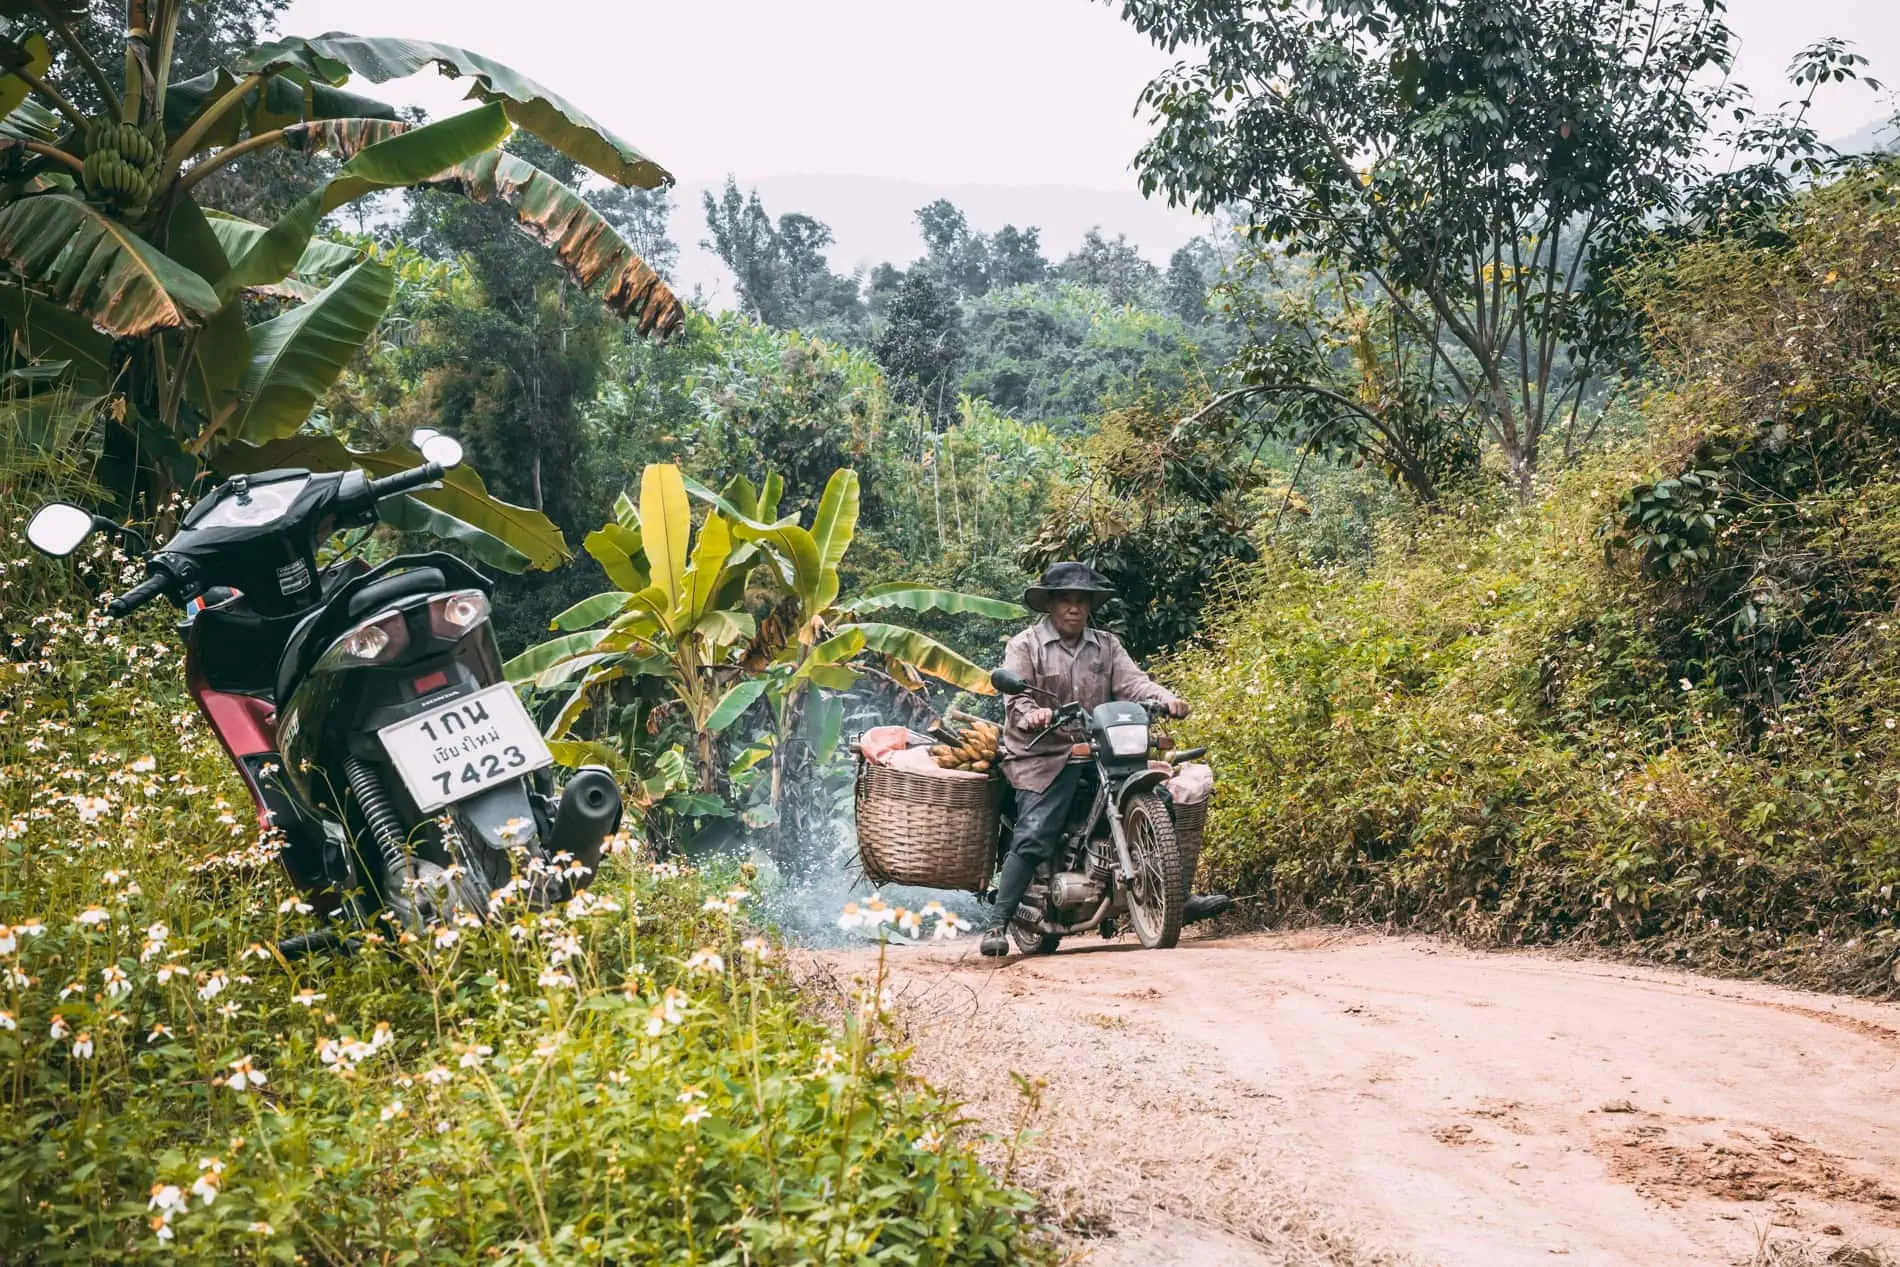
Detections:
[283, 0, 1900, 190]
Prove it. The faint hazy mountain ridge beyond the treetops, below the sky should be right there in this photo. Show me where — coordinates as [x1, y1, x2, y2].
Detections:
[671, 173, 1212, 308]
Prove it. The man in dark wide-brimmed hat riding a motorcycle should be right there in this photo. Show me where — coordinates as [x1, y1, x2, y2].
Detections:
[982, 562, 1233, 957]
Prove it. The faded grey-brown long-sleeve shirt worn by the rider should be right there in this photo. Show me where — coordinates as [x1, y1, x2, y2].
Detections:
[1003, 615, 1174, 792]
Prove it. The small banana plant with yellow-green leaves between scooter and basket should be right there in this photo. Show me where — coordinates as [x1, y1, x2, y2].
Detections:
[509, 465, 1024, 835]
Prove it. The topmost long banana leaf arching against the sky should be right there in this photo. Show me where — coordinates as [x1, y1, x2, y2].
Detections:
[243, 30, 673, 188]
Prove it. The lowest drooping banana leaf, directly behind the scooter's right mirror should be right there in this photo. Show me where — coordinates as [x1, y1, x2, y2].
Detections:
[211, 435, 568, 570]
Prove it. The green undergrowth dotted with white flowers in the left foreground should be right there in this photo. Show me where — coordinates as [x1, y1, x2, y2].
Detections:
[0, 463, 1037, 1263]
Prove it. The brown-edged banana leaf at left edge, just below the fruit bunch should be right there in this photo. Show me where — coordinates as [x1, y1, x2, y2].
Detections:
[0, 194, 222, 338]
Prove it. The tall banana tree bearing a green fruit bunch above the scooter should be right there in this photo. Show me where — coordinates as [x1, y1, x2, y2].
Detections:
[0, 0, 682, 568]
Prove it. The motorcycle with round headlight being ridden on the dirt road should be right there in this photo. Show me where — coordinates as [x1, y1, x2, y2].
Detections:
[990, 669, 1207, 954]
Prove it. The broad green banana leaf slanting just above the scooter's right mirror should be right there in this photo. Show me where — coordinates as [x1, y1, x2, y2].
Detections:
[220, 260, 395, 444]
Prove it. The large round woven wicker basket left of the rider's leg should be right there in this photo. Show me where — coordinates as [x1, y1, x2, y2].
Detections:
[857, 760, 998, 893]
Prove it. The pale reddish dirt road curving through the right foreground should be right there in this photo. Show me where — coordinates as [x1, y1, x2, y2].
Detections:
[832, 933, 1900, 1267]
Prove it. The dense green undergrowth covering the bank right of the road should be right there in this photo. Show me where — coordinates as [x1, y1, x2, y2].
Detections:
[1170, 171, 1900, 992]
